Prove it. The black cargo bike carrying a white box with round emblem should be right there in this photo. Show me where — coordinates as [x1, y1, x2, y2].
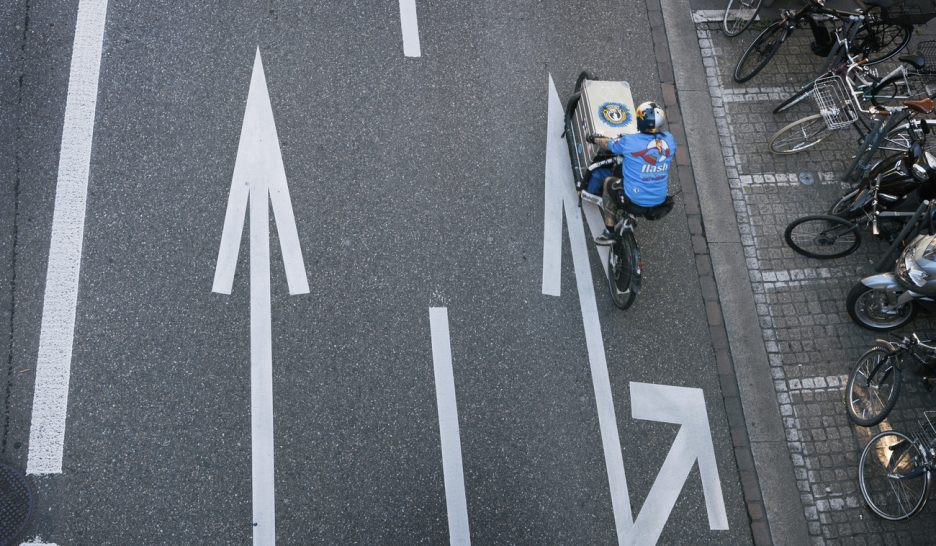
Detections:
[563, 72, 673, 309]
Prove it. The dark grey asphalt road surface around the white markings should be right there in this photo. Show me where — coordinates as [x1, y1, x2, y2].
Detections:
[0, 0, 750, 545]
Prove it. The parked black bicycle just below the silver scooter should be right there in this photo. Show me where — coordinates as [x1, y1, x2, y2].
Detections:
[845, 334, 936, 427]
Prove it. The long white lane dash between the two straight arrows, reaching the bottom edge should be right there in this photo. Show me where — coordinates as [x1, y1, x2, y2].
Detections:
[429, 307, 471, 546]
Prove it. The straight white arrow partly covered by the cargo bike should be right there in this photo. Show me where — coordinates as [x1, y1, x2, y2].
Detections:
[543, 76, 634, 544]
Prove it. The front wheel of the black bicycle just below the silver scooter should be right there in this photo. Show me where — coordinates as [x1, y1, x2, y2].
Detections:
[845, 342, 903, 427]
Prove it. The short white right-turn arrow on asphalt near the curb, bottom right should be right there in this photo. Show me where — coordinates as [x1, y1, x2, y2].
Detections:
[630, 383, 728, 544]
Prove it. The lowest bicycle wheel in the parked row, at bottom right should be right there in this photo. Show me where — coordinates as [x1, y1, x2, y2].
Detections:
[858, 430, 931, 521]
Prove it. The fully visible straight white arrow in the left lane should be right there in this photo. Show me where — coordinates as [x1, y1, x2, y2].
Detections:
[212, 48, 309, 545]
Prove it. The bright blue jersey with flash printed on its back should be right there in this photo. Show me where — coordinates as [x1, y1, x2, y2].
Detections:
[608, 132, 676, 207]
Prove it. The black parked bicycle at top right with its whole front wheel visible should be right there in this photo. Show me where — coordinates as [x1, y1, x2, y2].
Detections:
[733, 0, 913, 83]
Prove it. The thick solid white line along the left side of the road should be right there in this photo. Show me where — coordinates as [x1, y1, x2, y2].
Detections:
[26, 0, 107, 474]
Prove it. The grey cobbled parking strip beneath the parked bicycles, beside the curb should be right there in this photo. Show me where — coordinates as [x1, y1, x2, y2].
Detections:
[681, 10, 936, 544]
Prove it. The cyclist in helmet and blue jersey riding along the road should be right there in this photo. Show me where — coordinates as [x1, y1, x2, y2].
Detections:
[585, 102, 676, 245]
